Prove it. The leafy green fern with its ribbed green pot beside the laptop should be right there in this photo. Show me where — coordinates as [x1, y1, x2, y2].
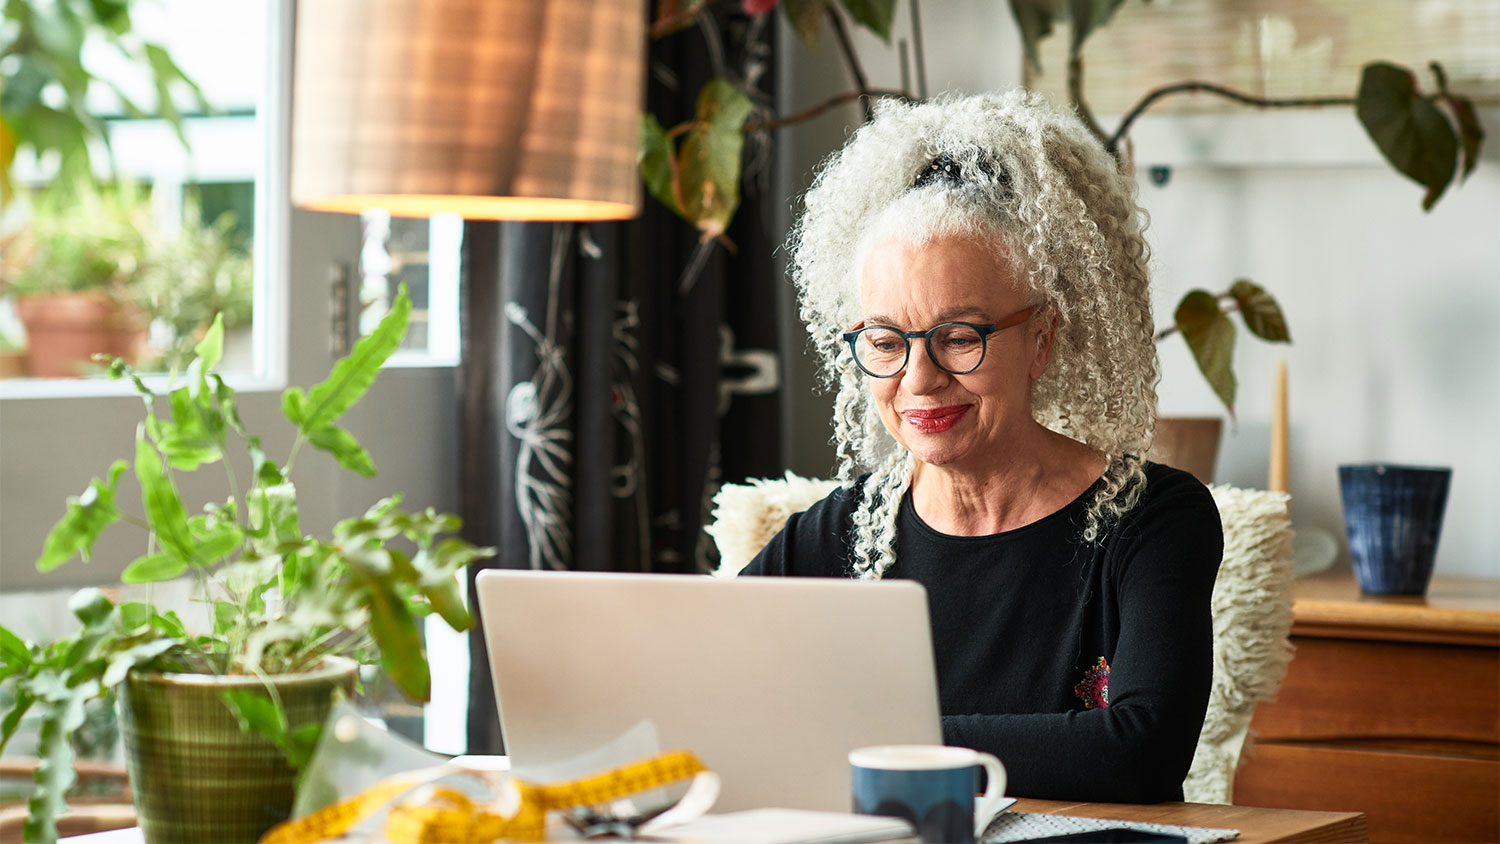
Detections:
[0, 288, 492, 841]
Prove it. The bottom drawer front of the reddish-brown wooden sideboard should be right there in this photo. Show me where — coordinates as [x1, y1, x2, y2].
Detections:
[1235, 742, 1500, 841]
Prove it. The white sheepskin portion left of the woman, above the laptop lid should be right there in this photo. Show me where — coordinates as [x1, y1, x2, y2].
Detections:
[705, 472, 839, 577]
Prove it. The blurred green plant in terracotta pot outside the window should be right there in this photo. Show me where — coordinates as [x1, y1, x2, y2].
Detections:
[0, 186, 150, 378]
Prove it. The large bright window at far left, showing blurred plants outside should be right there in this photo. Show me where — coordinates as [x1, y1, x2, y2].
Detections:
[0, 0, 267, 397]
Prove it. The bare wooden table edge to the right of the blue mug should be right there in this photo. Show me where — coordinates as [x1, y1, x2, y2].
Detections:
[1011, 798, 1370, 844]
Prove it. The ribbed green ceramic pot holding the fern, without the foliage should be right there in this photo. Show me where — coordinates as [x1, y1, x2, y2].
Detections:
[120, 657, 359, 844]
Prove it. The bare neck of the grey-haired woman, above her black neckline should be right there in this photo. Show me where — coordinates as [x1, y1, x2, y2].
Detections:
[912, 423, 1106, 537]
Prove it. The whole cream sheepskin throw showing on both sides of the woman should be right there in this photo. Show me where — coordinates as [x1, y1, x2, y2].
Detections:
[707, 472, 1292, 804]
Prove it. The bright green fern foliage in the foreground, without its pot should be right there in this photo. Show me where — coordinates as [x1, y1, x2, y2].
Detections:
[0, 288, 492, 841]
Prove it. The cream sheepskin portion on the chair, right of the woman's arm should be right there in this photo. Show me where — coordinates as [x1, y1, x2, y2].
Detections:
[1182, 486, 1293, 804]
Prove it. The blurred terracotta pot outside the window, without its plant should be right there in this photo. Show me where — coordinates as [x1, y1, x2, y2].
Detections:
[17, 291, 150, 378]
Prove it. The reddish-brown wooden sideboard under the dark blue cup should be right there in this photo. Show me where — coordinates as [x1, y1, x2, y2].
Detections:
[1235, 571, 1500, 841]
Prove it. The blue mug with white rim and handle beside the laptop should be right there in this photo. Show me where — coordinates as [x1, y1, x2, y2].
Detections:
[849, 745, 1005, 844]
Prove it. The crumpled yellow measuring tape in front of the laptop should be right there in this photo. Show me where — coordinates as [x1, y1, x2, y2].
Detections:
[261, 751, 708, 844]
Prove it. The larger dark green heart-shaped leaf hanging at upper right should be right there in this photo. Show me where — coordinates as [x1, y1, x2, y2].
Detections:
[1356, 61, 1458, 210]
